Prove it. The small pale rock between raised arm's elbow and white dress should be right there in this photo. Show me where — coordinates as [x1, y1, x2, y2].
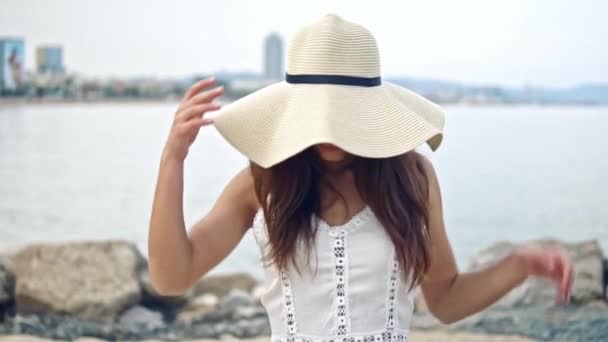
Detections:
[194, 273, 258, 298]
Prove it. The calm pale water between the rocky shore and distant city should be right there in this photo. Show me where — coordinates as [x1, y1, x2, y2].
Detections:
[0, 104, 608, 276]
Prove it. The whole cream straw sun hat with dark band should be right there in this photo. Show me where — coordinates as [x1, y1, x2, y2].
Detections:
[214, 14, 444, 168]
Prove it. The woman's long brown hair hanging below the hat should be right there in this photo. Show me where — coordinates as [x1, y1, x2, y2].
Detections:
[249, 147, 430, 290]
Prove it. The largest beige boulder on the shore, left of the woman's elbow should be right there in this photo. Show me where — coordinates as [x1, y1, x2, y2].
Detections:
[13, 241, 144, 321]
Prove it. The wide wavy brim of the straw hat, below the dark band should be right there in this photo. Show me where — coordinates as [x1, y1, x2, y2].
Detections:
[214, 81, 445, 168]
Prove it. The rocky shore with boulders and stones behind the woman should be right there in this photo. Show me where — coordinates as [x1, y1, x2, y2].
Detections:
[0, 240, 608, 342]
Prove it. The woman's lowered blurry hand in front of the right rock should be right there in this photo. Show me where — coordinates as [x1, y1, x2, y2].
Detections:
[513, 244, 574, 304]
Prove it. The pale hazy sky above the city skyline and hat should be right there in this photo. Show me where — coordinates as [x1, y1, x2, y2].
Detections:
[0, 0, 608, 87]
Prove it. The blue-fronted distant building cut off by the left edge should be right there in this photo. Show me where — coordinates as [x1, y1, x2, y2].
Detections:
[0, 38, 25, 94]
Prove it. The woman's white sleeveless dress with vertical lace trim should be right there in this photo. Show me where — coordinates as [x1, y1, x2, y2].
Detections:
[252, 206, 414, 342]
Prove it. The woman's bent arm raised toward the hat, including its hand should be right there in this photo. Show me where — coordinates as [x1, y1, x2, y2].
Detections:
[148, 79, 257, 295]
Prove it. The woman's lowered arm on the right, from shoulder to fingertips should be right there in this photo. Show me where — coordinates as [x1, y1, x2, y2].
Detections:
[420, 157, 573, 324]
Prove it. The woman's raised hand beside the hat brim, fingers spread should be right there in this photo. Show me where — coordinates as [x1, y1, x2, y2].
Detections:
[163, 77, 224, 161]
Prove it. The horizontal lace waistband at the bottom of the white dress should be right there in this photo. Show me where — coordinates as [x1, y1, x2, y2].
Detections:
[270, 329, 408, 342]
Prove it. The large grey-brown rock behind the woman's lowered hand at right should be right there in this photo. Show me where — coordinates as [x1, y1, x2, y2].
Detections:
[467, 239, 603, 308]
